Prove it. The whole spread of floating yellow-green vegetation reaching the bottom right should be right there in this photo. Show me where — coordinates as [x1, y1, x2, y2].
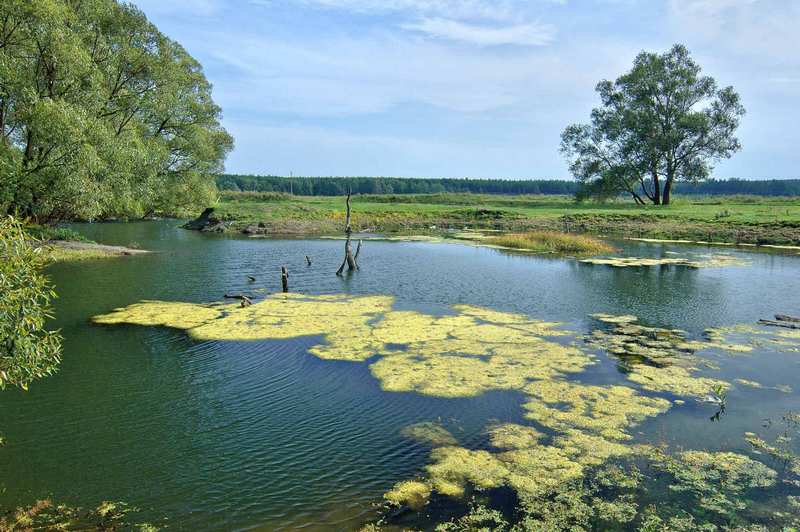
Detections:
[94, 294, 800, 530]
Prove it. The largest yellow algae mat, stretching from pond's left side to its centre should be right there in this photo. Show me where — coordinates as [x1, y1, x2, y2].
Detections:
[94, 294, 592, 397]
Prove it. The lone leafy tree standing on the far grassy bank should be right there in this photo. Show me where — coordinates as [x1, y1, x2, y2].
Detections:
[561, 45, 745, 205]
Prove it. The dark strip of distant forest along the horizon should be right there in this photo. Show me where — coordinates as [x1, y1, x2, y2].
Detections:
[217, 174, 800, 196]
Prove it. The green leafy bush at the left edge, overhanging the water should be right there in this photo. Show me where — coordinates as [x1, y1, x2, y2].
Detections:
[0, 218, 61, 389]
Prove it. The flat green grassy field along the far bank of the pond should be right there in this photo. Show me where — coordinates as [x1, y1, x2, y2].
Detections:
[215, 192, 800, 245]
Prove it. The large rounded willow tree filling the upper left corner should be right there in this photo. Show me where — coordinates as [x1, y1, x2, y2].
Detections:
[0, 0, 232, 221]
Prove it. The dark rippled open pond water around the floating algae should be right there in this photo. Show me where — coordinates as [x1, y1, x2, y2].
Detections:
[0, 222, 800, 530]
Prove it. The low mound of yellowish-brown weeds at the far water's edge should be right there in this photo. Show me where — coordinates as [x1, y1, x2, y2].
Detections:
[486, 231, 615, 256]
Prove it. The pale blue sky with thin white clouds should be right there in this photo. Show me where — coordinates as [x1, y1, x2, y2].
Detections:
[134, 0, 800, 179]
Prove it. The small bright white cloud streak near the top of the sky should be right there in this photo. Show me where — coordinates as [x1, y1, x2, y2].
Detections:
[403, 18, 556, 46]
